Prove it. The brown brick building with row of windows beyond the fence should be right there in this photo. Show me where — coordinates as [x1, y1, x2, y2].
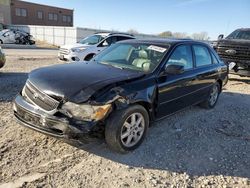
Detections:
[0, 0, 74, 27]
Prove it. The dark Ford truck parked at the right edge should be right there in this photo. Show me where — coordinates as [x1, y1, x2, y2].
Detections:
[213, 28, 250, 76]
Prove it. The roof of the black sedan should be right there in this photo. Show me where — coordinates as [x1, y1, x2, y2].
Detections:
[119, 38, 208, 46]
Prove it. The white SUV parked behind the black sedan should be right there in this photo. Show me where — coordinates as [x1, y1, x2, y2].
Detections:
[58, 33, 134, 62]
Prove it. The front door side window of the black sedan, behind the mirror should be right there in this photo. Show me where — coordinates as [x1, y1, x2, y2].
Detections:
[166, 45, 193, 70]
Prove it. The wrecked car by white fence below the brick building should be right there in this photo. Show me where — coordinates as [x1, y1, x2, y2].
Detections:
[0, 29, 35, 45]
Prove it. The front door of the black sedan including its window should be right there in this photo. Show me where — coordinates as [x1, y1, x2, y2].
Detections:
[157, 45, 196, 118]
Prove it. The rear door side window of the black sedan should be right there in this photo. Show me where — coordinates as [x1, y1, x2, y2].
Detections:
[193, 45, 212, 67]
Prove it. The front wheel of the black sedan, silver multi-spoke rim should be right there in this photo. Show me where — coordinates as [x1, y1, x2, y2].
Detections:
[105, 105, 149, 153]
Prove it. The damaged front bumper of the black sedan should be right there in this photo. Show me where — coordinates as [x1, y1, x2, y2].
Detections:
[13, 95, 102, 142]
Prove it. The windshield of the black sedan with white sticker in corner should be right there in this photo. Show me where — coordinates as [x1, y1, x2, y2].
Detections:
[94, 43, 169, 73]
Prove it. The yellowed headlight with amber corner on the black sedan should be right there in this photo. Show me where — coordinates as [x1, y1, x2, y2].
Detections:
[61, 102, 111, 121]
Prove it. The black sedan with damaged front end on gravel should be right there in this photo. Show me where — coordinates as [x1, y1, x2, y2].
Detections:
[14, 40, 228, 152]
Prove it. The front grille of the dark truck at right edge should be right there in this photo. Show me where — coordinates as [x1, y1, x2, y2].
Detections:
[217, 44, 250, 61]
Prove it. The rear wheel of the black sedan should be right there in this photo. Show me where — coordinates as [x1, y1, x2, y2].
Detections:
[200, 82, 220, 109]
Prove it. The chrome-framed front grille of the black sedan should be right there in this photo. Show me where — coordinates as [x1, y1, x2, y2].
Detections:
[24, 81, 60, 111]
